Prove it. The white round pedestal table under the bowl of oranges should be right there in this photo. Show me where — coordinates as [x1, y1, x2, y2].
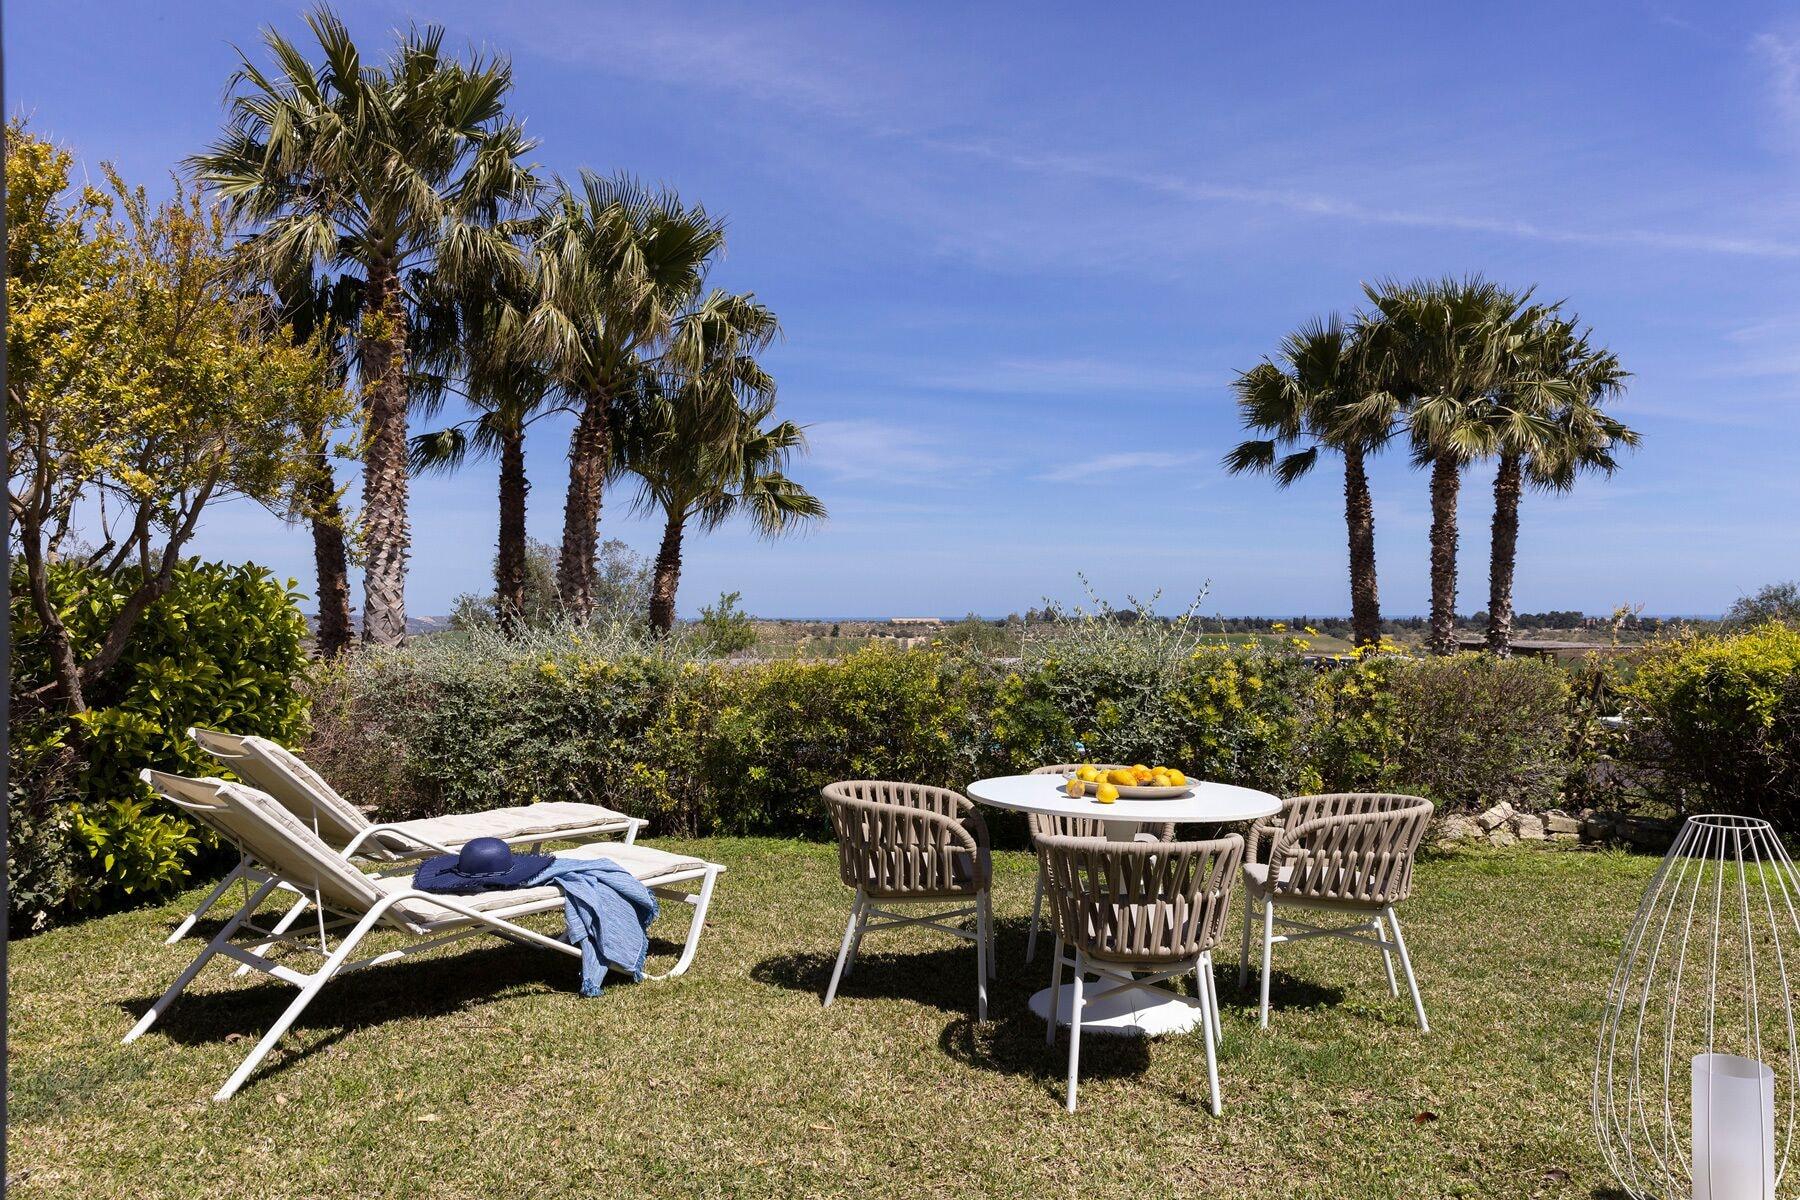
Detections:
[967, 775, 1282, 1038]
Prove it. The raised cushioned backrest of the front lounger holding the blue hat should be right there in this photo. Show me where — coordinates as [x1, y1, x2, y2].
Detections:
[140, 770, 392, 914]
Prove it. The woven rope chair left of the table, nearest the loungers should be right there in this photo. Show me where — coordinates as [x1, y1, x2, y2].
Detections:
[819, 779, 995, 1020]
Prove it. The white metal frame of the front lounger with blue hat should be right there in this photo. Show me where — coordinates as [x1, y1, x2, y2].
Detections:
[124, 770, 725, 1101]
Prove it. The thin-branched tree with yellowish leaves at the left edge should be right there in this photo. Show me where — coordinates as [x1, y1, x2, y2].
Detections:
[5, 122, 344, 714]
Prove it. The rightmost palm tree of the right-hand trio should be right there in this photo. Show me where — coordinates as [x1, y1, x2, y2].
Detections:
[1487, 317, 1638, 658]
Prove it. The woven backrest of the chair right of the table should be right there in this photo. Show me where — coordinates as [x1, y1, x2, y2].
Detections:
[1269, 792, 1431, 905]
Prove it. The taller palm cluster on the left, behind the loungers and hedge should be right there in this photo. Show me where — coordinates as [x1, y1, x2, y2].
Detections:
[191, 7, 824, 655]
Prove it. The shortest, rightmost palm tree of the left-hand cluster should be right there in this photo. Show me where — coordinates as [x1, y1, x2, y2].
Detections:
[616, 291, 824, 635]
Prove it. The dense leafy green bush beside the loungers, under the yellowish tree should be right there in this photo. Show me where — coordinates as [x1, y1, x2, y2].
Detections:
[9, 561, 306, 925]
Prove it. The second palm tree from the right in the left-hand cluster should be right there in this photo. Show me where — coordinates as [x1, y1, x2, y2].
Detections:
[529, 171, 725, 621]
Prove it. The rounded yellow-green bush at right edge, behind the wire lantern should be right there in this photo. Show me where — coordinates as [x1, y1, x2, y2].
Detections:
[1620, 622, 1800, 831]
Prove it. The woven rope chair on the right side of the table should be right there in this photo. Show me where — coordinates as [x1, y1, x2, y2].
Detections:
[1238, 793, 1431, 1033]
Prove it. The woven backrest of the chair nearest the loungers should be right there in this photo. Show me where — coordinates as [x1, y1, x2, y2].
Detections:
[819, 779, 988, 898]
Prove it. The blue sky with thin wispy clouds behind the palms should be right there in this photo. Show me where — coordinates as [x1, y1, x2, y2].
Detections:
[5, 0, 1800, 617]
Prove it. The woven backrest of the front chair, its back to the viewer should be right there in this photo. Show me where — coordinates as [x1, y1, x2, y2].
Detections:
[1037, 833, 1244, 963]
